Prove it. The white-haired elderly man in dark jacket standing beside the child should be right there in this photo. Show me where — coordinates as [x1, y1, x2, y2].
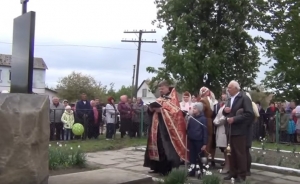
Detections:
[223, 81, 254, 182]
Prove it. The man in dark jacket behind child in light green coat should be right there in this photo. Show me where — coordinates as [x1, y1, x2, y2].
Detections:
[76, 93, 94, 139]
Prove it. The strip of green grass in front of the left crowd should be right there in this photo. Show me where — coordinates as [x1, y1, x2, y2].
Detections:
[50, 135, 147, 152]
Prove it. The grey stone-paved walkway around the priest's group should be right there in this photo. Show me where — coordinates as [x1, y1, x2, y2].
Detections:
[87, 148, 300, 184]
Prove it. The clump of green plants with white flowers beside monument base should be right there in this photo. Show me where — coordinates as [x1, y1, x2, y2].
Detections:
[49, 144, 86, 170]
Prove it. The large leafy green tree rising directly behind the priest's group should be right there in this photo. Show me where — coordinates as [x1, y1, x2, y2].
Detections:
[147, 0, 261, 95]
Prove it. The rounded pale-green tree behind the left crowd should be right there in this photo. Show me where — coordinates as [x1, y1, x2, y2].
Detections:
[56, 72, 106, 102]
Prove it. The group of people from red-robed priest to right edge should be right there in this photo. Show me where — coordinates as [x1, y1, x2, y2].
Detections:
[144, 81, 300, 182]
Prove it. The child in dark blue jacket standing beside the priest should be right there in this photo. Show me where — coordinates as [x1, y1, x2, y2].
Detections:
[187, 102, 208, 176]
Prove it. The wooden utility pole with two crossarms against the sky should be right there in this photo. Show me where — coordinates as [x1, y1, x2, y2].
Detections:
[121, 30, 157, 97]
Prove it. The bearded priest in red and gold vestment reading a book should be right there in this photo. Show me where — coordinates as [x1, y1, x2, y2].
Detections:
[144, 81, 187, 175]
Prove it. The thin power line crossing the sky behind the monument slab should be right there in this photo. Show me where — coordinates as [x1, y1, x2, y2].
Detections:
[0, 41, 162, 56]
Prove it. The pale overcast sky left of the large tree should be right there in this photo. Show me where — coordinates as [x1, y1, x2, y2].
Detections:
[0, 0, 267, 88]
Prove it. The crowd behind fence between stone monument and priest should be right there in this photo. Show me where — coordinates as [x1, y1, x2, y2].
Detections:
[50, 93, 148, 141]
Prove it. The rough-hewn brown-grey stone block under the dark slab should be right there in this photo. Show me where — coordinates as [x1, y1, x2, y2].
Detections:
[0, 93, 50, 184]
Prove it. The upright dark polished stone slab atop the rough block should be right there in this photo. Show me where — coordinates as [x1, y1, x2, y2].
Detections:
[10, 0, 35, 93]
